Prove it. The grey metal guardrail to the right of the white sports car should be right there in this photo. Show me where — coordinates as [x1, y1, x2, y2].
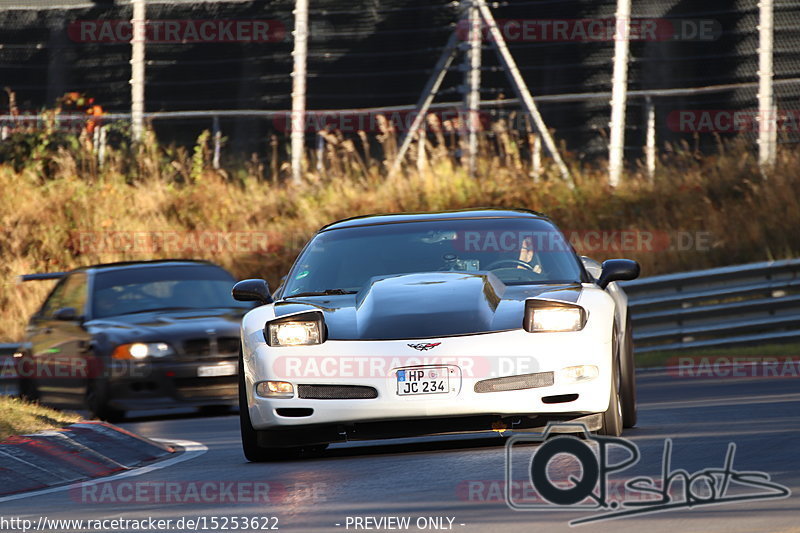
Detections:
[621, 259, 800, 353]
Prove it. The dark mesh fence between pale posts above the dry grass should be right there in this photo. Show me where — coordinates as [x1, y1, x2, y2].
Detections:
[0, 0, 800, 168]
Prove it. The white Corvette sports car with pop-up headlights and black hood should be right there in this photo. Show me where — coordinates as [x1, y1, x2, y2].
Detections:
[233, 209, 639, 461]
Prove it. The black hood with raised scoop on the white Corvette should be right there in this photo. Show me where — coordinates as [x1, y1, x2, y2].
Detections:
[275, 272, 581, 340]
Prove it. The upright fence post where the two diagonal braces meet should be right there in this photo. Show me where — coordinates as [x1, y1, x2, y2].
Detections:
[464, 0, 483, 178]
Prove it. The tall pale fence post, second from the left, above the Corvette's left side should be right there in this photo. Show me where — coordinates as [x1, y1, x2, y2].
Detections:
[292, 0, 308, 183]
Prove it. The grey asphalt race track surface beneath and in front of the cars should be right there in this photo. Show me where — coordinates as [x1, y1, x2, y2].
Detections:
[0, 372, 800, 533]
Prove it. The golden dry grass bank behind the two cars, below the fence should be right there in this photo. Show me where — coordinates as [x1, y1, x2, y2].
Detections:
[0, 124, 800, 341]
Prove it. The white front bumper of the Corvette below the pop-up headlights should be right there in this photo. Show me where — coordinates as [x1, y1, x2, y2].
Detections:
[243, 328, 612, 433]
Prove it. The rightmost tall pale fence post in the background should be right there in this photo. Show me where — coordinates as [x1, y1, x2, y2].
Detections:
[758, 0, 777, 173]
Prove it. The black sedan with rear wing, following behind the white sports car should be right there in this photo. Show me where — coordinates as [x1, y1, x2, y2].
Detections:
[15, 260, 252, 420]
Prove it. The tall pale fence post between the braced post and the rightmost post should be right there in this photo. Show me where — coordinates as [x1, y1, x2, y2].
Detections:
[608, 0, 631, 187]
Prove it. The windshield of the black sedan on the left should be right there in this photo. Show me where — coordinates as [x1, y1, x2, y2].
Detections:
[92, 264, 252, 318]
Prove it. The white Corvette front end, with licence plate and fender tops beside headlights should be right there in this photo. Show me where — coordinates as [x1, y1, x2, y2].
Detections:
[242, 288, 613, 430]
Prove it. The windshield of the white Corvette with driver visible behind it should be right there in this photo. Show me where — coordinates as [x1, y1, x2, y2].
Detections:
[282, 217, 582, 297]
